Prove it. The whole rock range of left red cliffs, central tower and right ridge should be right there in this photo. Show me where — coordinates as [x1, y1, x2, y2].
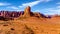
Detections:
[0, 6, 51, 19]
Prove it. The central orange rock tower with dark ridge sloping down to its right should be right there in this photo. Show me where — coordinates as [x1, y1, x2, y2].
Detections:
[20, 6, 51, 18]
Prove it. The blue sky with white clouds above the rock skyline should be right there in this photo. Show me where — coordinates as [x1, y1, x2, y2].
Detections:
[0, 0, 60, 15]
